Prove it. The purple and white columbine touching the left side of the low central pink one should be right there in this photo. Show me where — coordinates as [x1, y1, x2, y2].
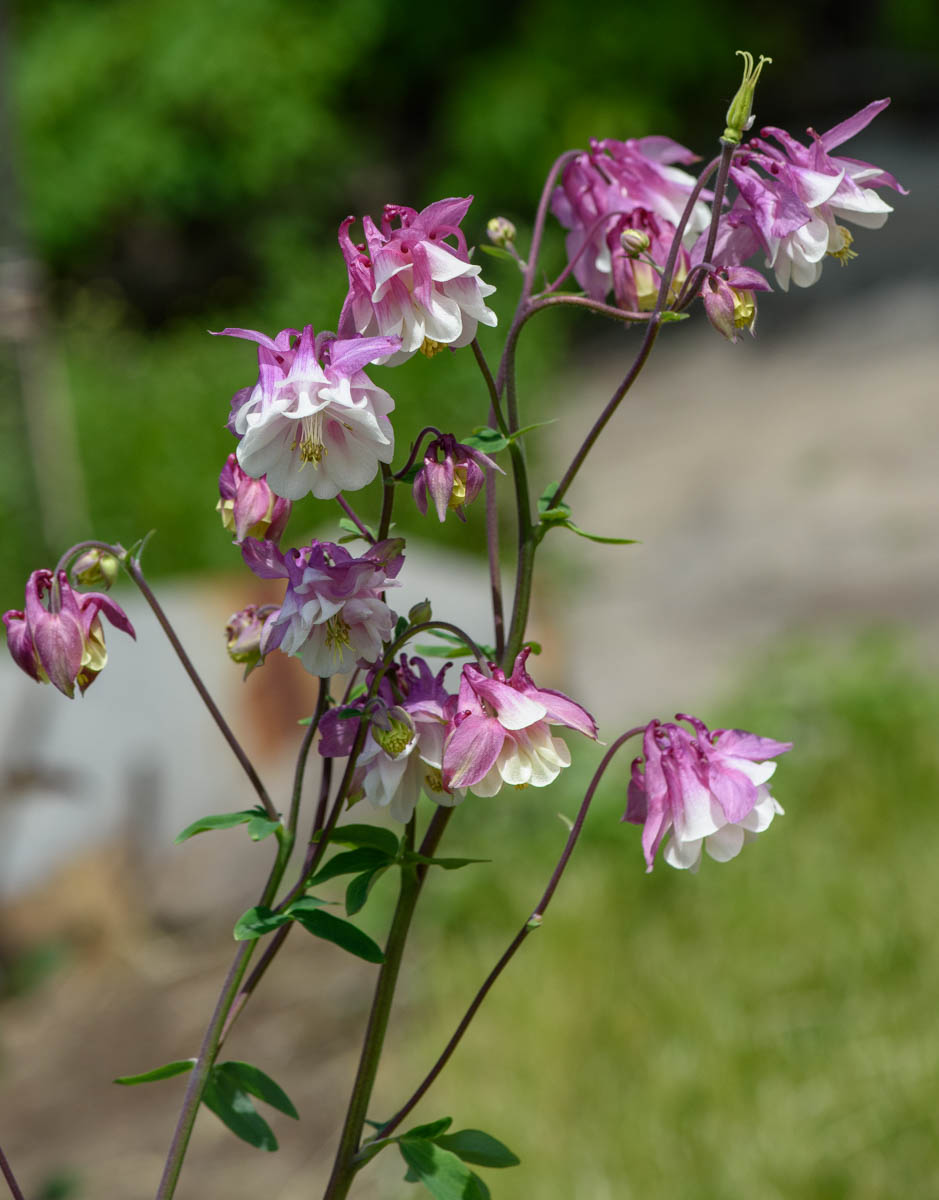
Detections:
[319, 654, 462, 821]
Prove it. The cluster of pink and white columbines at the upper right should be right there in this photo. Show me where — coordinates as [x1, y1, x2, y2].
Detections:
[551, 100, 905, 341]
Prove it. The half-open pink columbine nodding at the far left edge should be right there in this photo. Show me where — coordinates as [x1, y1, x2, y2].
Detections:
[4, 570, 136, 700]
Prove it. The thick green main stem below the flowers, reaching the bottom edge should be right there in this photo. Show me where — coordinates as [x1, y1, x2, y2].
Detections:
[323, 808, 453, 1200]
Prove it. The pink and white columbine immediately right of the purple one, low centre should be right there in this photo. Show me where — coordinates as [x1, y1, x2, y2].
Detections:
[443, 647, 597, 796]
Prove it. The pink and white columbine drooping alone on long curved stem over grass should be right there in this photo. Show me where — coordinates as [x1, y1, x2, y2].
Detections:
[623, 713, 793, 871]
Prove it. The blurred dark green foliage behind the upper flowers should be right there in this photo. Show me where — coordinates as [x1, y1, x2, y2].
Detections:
[0, 0, 937, 602]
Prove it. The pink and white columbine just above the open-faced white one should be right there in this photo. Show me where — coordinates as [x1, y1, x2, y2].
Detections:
[339, 196, 497, 366]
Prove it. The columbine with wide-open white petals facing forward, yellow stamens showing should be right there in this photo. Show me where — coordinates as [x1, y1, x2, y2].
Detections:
[222, 325, 400, 500]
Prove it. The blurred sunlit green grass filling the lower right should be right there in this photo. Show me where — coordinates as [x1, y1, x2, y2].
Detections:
[376, 635, 939, 1200]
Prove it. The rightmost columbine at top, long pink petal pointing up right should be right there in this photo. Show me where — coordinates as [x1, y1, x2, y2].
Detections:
[730, 100, 907, 292]
